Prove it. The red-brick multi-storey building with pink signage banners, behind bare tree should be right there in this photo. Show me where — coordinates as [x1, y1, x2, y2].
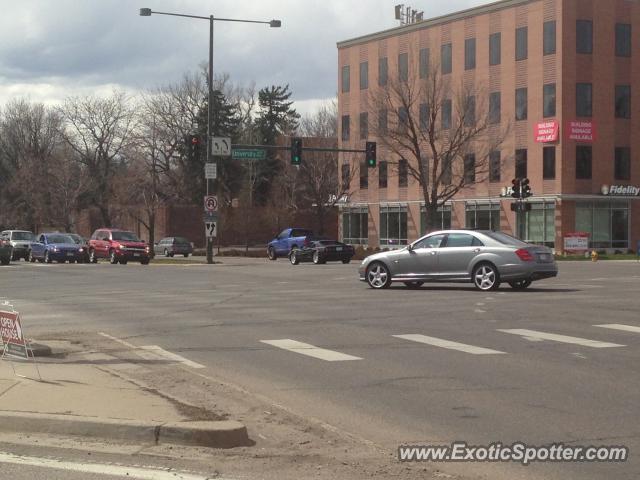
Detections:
[338, 0, 640, 255]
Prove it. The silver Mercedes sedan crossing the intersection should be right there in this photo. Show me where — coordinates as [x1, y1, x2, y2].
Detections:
[358, 230, 558, 291]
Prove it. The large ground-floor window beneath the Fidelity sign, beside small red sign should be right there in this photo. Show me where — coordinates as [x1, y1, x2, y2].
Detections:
[576, 200, 629, 249]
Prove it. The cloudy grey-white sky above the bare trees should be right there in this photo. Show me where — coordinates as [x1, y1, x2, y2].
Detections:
[0, 0, 490, 113]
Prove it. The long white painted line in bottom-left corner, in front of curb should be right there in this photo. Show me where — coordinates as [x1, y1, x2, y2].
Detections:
[0, 452, 211, 480]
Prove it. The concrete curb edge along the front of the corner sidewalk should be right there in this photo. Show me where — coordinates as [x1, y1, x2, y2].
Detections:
[0, 411, 253, 448]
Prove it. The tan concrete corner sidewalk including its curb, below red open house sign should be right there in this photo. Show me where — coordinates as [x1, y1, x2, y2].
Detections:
[0, 342, 251, 448]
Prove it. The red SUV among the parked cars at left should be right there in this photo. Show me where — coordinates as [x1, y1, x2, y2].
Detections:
[89, 228, 150, 265]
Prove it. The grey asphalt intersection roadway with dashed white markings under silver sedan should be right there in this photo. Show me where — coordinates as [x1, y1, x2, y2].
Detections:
[0, 258, 640, 480]
